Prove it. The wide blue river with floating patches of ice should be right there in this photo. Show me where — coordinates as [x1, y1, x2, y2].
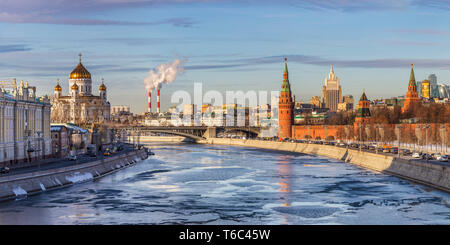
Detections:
[0, 143, 450, 225]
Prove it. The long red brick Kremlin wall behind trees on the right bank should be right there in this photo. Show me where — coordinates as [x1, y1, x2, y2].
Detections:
[292, 123, 450, 144]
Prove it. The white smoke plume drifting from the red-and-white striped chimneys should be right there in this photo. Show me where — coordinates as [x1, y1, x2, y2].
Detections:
[144, 59, 186, 91]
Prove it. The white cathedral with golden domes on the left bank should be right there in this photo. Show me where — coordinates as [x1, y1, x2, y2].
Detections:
[51, 54, 110, 124]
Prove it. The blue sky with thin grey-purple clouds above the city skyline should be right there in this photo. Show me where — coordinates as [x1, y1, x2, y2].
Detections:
[0, 0, 450, 113]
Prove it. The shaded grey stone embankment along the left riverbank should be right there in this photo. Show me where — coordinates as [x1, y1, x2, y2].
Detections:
[0, 150, 147, 201]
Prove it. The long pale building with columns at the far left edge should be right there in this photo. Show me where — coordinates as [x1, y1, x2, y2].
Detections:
[0, 81, 52, 166]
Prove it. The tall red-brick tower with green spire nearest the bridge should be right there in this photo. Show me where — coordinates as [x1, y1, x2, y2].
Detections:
[278, 58, 294, 139]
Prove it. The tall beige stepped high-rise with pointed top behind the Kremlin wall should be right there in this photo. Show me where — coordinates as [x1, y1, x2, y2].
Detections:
[323, 66, 342, 111]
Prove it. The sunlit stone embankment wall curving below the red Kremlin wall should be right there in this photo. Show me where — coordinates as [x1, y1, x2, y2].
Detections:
[198, 138, 450, 193]
